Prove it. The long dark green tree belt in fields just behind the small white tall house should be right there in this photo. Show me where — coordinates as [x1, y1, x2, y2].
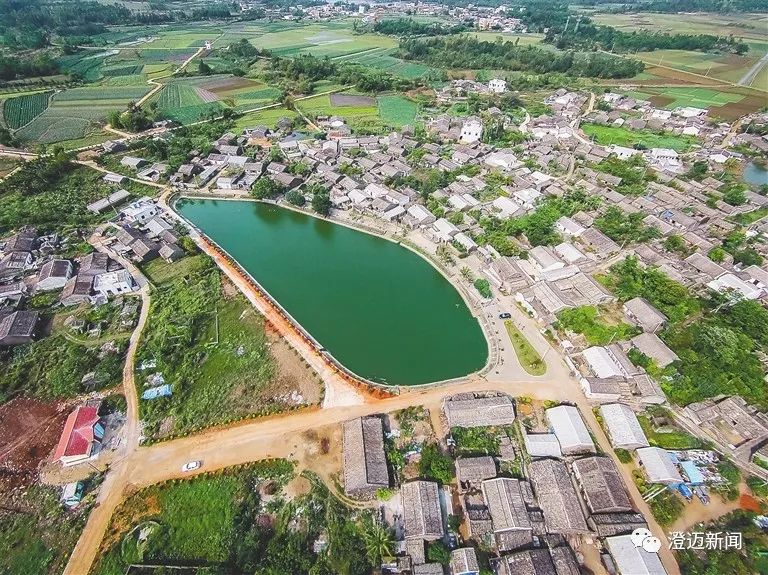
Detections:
[398, 36, 644, 78]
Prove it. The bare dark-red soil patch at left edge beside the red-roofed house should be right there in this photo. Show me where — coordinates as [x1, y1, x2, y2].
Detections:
[0, 397, 69, 491]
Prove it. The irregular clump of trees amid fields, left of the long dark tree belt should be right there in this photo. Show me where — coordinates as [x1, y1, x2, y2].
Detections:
[267, 55, 415, 94]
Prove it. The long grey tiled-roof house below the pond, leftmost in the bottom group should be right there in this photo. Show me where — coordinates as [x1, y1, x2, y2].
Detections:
[342, 416, 389, 498]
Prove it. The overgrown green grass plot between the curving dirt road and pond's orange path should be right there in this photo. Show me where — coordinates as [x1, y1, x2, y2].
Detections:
[137, 256, 281, 438]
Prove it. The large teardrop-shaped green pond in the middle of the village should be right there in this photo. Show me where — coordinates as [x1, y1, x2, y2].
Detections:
[176, 199, 488, 385]
